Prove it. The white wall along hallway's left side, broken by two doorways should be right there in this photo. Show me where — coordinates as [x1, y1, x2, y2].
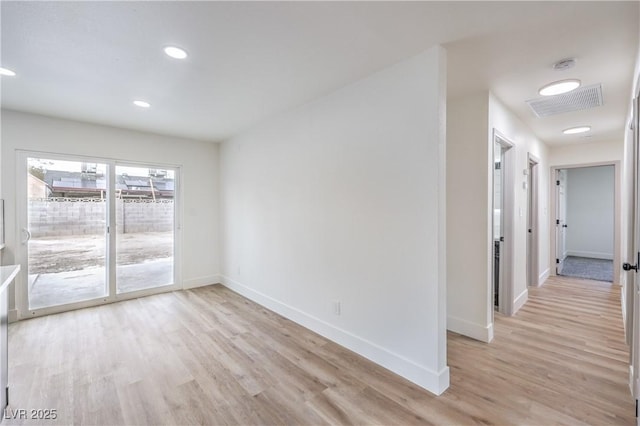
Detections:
[447, 92, 549, 342]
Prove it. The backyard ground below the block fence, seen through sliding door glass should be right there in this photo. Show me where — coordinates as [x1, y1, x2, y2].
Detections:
[29, 232, 174, 309]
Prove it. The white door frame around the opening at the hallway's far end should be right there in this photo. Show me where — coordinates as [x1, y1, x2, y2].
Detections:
[549, 160, 622, 285]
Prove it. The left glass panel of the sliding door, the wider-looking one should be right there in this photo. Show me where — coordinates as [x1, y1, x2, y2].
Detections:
[26, 157, 108, 310]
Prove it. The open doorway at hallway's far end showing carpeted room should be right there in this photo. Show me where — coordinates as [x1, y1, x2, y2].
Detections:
[556, 165, 616, 282]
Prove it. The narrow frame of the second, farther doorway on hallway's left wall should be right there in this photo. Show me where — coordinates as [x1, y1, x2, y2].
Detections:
[527, 153, 540, 287]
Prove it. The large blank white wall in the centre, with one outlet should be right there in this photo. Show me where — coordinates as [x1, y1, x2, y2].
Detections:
[221, 47, 449, 394]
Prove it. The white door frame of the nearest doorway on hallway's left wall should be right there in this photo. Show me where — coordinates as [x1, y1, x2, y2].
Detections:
[488, 128, 516, 316]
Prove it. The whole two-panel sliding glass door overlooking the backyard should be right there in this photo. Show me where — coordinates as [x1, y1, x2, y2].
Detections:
[18, 153, 179, 315]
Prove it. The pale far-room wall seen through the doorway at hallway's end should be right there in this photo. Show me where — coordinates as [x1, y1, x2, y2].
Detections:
[567, 166, 615, 259]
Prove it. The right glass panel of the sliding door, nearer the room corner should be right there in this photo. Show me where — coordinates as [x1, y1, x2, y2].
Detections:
[115, 165, 176, 294]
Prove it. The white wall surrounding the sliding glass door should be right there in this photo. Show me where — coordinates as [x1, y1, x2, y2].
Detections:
[1, 110, 220, 318]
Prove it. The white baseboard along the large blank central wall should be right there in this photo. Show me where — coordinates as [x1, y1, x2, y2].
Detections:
[221, 275, 449, 395]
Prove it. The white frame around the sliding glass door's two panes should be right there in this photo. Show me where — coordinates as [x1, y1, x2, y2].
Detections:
[15, 150, 182, 320]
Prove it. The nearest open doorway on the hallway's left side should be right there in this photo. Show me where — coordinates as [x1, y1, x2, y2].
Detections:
[491, 130, 515, 315]
